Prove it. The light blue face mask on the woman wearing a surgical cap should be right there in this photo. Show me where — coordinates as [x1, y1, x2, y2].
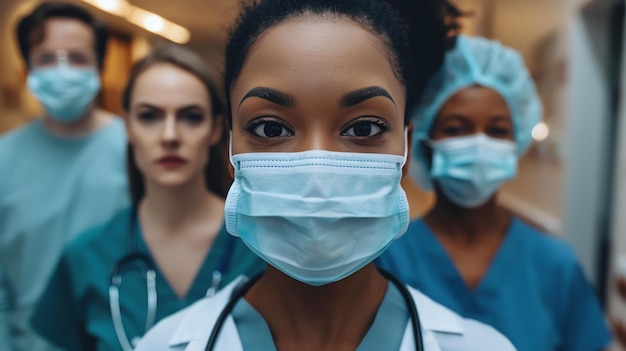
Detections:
[429, 134, 517, 208]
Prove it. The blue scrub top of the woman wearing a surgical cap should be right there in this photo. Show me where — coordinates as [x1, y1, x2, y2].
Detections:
[377, 219, 612, 351]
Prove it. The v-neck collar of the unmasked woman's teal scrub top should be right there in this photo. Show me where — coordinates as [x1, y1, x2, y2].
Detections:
[136, 222, 229, 303]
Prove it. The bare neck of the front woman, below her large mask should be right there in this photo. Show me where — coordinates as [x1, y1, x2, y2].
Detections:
[246, 264, 388, 351]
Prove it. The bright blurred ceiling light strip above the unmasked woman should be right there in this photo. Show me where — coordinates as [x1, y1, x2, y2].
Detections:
[82, 0, 191, 44]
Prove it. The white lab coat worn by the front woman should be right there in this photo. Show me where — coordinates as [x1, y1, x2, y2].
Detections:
[135, 278, 515, 351]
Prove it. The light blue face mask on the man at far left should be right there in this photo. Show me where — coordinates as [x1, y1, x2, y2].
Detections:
[28, 63, 100, 123]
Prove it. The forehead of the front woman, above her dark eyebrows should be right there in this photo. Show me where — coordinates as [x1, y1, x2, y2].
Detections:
[232, 16, 405, 103]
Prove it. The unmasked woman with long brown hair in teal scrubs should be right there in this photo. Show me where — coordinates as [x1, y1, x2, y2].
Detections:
[32, 46, 265, 351]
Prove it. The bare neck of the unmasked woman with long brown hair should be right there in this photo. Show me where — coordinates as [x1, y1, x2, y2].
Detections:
[139, 174, 224, 233]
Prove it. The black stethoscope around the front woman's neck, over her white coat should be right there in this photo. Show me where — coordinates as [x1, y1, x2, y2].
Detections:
[204, 268, 424, 351]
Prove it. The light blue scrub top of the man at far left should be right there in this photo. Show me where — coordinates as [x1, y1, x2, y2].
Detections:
[0, 118, 129, 351]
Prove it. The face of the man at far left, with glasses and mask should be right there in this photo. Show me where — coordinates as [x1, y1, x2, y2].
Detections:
[27, 18, 100, 123]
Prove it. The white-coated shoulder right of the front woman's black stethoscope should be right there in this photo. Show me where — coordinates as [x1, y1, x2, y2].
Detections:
[408, 287, 515, 351]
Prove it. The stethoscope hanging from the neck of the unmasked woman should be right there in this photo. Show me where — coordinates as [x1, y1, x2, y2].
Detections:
[109, 207, 235, 351]
